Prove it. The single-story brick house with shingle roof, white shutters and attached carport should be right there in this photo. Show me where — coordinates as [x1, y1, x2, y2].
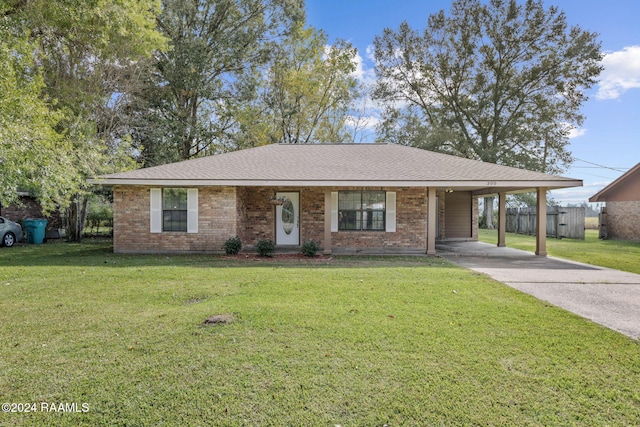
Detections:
[90, 144, 582, 255]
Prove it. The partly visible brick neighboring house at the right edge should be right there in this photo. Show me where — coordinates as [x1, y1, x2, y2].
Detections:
[589, 163, 640, 240]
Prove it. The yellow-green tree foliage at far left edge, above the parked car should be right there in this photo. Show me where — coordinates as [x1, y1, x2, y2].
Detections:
[0, 21, 73, 212]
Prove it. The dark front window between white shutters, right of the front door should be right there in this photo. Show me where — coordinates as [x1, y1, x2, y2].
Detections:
[338, 191, 386, 231]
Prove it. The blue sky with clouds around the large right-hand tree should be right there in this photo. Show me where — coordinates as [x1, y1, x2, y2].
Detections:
[306, 0, 640, 204]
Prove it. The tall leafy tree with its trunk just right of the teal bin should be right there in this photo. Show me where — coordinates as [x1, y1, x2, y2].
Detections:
[0, 0, 164, 240]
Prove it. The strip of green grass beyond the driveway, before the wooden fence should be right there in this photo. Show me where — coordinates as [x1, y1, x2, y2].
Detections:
[478, 229, 640, 274]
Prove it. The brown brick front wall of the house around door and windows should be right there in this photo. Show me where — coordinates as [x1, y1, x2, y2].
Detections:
[113, 186, 478, 253]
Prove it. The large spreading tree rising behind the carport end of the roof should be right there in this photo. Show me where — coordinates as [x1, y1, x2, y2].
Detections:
[374, 0, 602, 227]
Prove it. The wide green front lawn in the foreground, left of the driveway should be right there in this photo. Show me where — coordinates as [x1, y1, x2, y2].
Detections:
[0, 243, 640, 426]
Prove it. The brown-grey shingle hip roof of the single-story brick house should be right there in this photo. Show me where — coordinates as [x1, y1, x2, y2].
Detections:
[92, 144, 582, 188]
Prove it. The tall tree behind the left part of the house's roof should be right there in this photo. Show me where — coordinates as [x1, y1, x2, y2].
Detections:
[127, 0, 304, 166]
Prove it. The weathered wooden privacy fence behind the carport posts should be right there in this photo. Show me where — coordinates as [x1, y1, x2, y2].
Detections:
[506, 206, 585, 240]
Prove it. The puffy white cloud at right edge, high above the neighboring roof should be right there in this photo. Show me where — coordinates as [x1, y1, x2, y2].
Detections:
[596, 46, 640, 99]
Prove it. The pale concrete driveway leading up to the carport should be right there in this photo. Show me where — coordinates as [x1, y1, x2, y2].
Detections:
[436, 242, 640, 339]
